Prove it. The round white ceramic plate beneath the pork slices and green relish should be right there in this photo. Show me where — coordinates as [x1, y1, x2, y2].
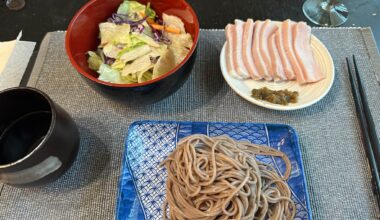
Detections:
[220, 35, 335, 110]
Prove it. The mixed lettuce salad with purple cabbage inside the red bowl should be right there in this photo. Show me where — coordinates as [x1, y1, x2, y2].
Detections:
[87, 0, 194, 84]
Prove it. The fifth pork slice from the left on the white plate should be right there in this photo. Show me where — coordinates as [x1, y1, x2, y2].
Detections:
[259, 19, 278, 80]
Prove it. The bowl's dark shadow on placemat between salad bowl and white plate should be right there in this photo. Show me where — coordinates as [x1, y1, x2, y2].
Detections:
[124, 41, 227, 115]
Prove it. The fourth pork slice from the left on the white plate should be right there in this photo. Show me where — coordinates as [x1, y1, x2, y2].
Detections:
[252, 21, 272, 80]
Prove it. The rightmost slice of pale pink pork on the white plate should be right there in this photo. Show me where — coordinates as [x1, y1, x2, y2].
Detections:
[293, 22, 325, 83]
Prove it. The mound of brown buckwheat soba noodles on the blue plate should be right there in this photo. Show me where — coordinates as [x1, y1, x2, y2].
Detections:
[162, 135, 296, 220]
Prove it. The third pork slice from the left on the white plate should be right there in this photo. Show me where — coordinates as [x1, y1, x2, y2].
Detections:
[243, 19, 262, 80]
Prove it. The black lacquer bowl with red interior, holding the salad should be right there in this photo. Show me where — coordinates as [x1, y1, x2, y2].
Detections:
[65, 0, 199, 103]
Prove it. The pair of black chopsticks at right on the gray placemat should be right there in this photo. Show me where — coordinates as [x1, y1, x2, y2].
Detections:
[346, 55, 380, 207]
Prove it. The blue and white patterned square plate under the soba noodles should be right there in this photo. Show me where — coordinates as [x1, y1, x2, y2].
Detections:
[116, 121, 312, 220]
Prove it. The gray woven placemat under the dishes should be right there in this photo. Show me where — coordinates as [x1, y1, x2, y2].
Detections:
[0, 29, 380, 219]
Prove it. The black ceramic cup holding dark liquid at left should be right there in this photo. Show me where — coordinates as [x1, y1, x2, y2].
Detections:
[0, 87, 79, 187]
